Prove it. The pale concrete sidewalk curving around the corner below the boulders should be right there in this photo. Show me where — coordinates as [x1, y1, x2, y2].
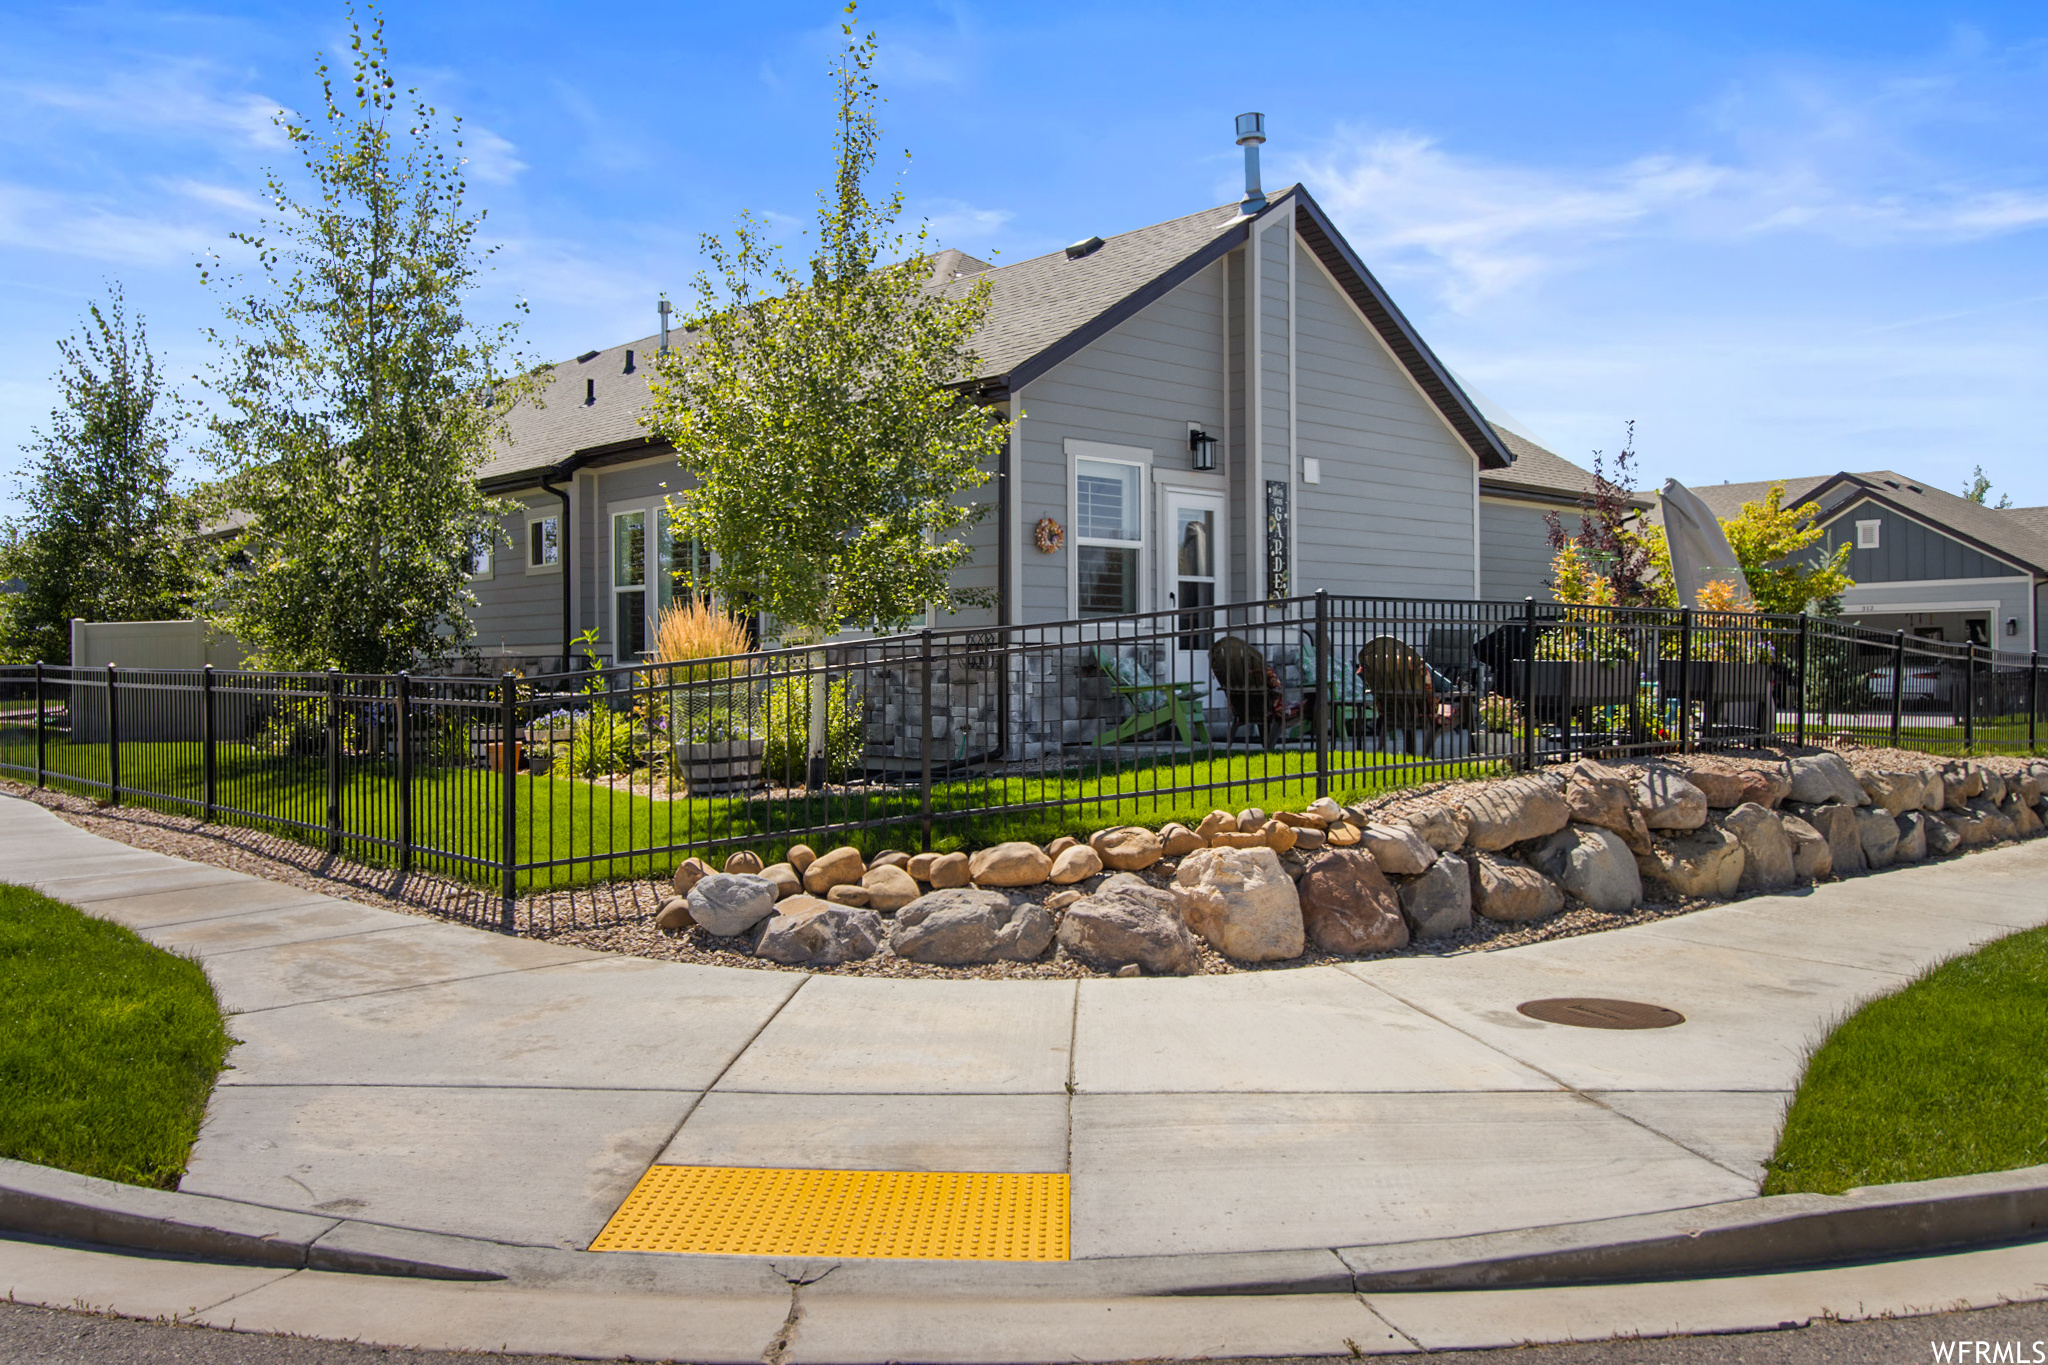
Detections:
[0, 800, 2048, 1268]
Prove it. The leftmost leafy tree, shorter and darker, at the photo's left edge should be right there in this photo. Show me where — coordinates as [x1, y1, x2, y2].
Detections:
[0, 284, 195, 663]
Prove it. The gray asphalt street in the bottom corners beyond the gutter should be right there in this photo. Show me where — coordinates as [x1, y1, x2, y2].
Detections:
[0, 1302, 2048, 1365]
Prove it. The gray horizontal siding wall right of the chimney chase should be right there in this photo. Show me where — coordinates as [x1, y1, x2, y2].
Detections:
[1294, 244, 1479, 598]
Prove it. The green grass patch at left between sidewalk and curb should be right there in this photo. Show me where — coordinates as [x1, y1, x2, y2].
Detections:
[0, 884, 231, 1189]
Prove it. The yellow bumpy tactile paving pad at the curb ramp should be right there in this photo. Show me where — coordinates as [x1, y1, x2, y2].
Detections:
[590, 1166, 1067, 1261]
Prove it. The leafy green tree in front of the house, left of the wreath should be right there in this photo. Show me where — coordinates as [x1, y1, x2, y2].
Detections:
[647, 6, 1006, 641]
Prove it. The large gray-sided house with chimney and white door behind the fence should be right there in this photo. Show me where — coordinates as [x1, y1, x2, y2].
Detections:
[475, 186, 1531, 667]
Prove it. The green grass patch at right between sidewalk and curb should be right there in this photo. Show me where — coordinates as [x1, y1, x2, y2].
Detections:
[1763, 916, 2048, 1195]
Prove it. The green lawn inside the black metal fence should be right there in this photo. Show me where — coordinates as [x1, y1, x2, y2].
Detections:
[0, 726, 1499, 890]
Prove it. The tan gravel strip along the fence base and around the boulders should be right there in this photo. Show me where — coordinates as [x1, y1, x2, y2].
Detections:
[0, 745, 2028, 980]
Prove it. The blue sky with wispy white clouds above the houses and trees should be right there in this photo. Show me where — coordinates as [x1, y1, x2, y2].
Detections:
[0, 0, 2048, 505]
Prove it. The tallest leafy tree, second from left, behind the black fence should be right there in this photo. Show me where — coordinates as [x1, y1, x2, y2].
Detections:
[203, 8, 532, 673]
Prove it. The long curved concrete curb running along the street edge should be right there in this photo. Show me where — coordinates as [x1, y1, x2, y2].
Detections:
[12, 1158, 2048, 1297]
